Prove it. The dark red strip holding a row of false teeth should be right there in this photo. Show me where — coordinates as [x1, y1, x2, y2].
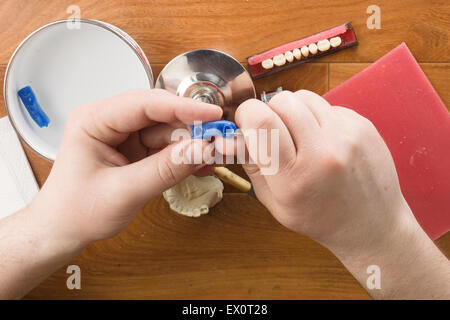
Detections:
[247, 22, 358, 79]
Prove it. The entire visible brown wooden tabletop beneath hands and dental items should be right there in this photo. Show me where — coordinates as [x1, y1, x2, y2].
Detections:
[0, 0, 450, 299]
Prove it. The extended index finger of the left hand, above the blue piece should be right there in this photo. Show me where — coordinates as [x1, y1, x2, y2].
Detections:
[71, 89, 222, 145]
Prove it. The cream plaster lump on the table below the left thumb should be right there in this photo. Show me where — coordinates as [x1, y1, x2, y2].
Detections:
[163, 176, 223, 217]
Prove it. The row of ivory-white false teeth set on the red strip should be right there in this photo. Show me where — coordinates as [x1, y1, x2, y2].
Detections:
[261, 37, 342, 69]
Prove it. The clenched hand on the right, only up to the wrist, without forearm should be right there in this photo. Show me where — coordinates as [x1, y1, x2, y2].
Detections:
[220, 90, 412, 255]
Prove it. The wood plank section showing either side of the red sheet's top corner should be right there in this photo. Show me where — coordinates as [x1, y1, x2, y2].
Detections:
[329, 63, 450, 110]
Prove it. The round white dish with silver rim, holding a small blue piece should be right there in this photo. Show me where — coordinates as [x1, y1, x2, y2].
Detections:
[4, 20, 153, 161]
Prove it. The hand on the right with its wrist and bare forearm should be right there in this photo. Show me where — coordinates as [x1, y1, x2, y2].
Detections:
[224, 90, 450, 299]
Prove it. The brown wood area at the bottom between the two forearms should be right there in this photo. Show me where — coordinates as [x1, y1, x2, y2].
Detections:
[23, 194, 368, 299]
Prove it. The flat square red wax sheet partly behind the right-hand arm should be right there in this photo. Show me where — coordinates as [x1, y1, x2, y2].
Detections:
[324, 43, 450, 240]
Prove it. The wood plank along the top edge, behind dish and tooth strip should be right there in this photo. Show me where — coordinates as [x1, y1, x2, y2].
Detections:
[0, 0, 450, 63]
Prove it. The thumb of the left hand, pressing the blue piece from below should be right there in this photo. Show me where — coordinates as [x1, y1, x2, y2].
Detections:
[112, 139, 210, 202]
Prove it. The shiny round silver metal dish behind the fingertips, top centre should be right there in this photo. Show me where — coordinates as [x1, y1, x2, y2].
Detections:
[155, 49, 256, 121]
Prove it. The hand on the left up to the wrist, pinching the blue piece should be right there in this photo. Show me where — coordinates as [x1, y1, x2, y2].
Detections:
[31, 89, 222, 248]
